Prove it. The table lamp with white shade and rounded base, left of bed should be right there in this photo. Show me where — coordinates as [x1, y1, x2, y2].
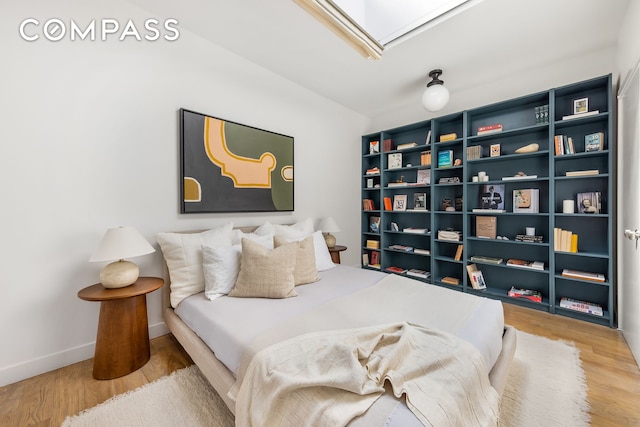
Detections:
[89, 226, 156, 288]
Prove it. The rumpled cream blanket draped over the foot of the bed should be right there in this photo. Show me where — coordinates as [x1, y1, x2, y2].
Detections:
[236, 323, 499, 427]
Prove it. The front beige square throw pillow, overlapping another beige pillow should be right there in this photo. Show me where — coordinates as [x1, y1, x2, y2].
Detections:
[229, 238, 299, 298]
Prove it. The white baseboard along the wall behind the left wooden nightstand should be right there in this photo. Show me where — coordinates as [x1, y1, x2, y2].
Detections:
[0, 322, 169, 387]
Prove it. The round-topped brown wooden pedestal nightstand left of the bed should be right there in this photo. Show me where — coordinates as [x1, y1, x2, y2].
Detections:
[78, 277, 164, 380]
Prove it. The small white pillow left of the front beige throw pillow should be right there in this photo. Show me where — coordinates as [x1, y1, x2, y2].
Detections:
[202, 245, 242, 301]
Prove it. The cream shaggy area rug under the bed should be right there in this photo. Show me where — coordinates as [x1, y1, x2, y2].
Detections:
[62, 331, 589, 427]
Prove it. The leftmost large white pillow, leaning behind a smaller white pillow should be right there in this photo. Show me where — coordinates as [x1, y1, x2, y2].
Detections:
[156, 222, 233, 308]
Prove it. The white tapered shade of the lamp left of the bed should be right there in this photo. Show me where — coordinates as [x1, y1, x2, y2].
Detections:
[89, 226, 156, 262]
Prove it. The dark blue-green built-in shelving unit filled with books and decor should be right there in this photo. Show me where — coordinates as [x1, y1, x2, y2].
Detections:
[362, 75, 616, 327]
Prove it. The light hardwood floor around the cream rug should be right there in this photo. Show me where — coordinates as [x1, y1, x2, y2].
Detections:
[0, 304, 640, 427]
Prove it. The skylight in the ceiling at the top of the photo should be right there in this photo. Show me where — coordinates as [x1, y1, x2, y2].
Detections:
[294, 0, 482, 59]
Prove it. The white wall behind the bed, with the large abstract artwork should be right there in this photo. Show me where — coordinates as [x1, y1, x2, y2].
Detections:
[0, 0, 366, 385]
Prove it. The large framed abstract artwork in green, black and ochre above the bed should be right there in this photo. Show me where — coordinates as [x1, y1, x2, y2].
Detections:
[180, 108, 294, 213]
